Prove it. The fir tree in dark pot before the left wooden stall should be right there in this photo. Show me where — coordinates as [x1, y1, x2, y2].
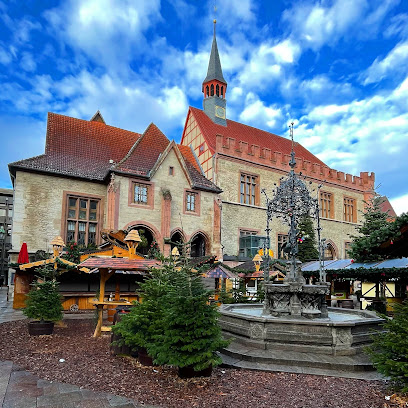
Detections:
[23, 265, 62, 336]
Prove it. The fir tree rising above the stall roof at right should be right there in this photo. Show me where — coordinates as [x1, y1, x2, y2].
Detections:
[349, 195, 390, 262]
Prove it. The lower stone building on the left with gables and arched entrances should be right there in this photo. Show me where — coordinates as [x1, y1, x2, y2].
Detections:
[9, 111, 221, 261]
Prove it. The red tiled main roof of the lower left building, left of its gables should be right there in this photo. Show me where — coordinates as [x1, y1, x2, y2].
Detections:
[9, 113, 140, 180]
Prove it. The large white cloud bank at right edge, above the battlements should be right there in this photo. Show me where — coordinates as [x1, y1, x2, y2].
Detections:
[295, 77, 408, 202]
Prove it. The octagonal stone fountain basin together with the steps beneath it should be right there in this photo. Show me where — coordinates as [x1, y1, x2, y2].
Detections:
[219, 304, 383, 379]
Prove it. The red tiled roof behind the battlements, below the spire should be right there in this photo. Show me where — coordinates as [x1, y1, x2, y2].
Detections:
[190, 106, 325, 165]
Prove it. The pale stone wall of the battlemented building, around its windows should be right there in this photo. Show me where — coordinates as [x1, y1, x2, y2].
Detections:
[216, 157, 364, 258]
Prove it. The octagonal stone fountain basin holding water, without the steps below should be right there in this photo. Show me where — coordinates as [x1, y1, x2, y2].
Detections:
[219, 304, 384, 356]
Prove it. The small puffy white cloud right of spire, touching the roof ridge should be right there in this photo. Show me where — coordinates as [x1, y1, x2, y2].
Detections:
[239, 92, 282, 128]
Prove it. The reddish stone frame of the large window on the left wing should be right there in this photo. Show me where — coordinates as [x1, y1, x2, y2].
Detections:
[61, 191, 105, 245]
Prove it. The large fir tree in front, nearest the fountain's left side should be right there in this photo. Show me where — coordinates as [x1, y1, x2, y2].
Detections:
[147, 266, 228, 371]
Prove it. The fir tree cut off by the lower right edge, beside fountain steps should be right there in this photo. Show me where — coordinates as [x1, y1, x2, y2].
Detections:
[367, 301, 408, 392]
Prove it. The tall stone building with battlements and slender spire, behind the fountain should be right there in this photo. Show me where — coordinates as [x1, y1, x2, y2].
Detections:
[181, 23, 374, 259]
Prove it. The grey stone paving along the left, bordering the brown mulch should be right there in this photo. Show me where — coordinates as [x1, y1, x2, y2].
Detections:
[0, 287, 158, 408]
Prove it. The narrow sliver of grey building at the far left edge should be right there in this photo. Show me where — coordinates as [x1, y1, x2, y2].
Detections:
[0, 188, 13, 285]
